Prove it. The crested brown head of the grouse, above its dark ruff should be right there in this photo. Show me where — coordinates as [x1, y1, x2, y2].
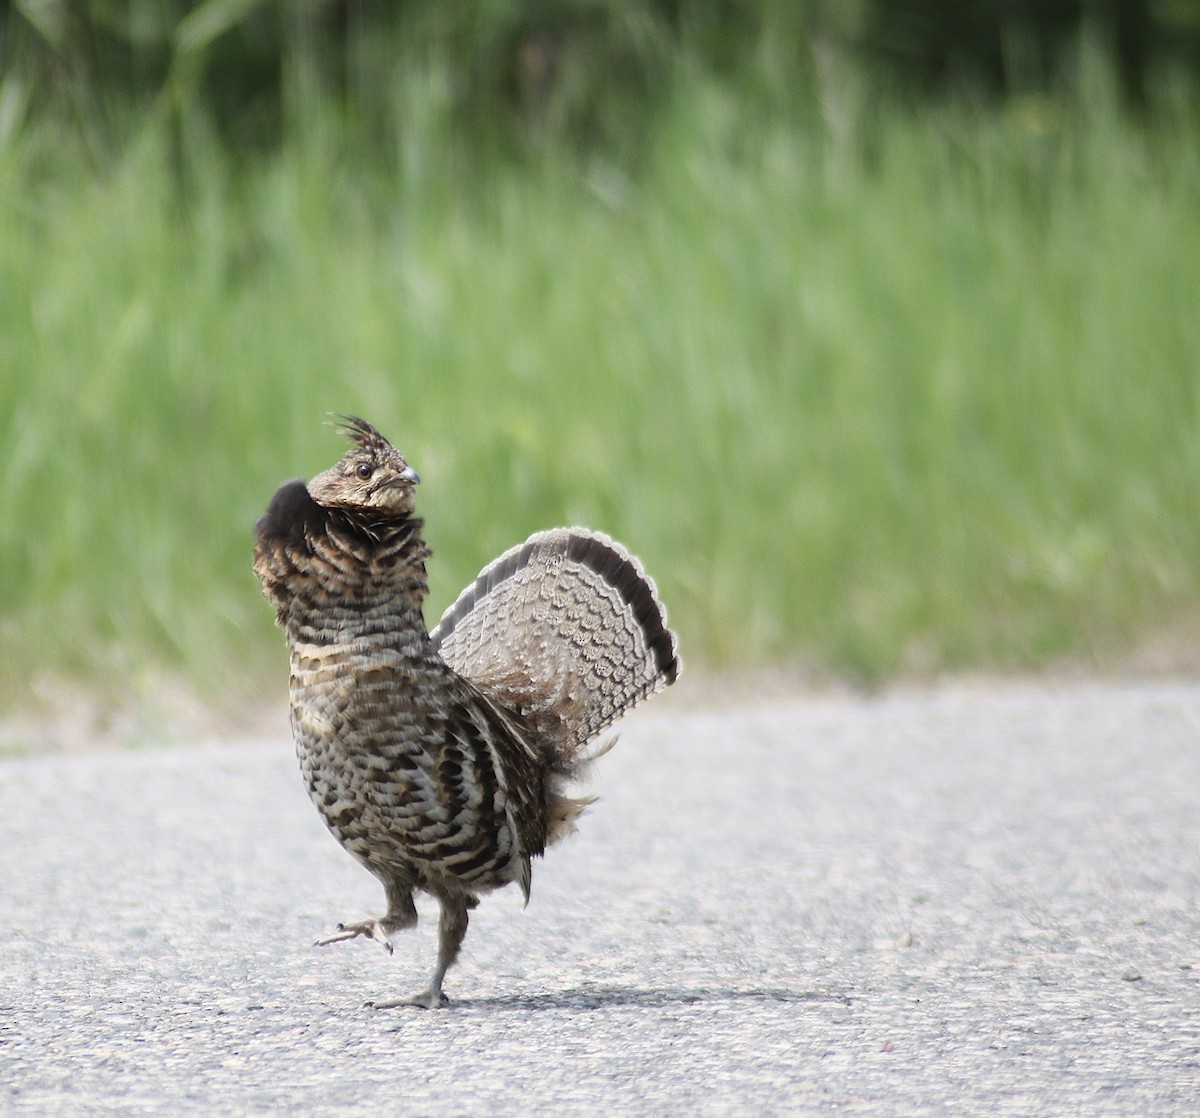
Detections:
[308, 415, 421, 518]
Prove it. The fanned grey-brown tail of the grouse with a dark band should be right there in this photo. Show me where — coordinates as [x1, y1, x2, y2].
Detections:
[432, 528, 680, 771]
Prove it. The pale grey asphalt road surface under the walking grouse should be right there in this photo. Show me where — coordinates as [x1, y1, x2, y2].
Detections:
[0, 684, 1200, 1114]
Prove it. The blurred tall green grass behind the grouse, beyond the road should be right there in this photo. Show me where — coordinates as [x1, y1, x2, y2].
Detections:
[0, 0, 1200, 729]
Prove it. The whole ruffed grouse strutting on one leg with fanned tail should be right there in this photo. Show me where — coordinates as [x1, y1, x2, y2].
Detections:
[254, 416, 680, 1008]
